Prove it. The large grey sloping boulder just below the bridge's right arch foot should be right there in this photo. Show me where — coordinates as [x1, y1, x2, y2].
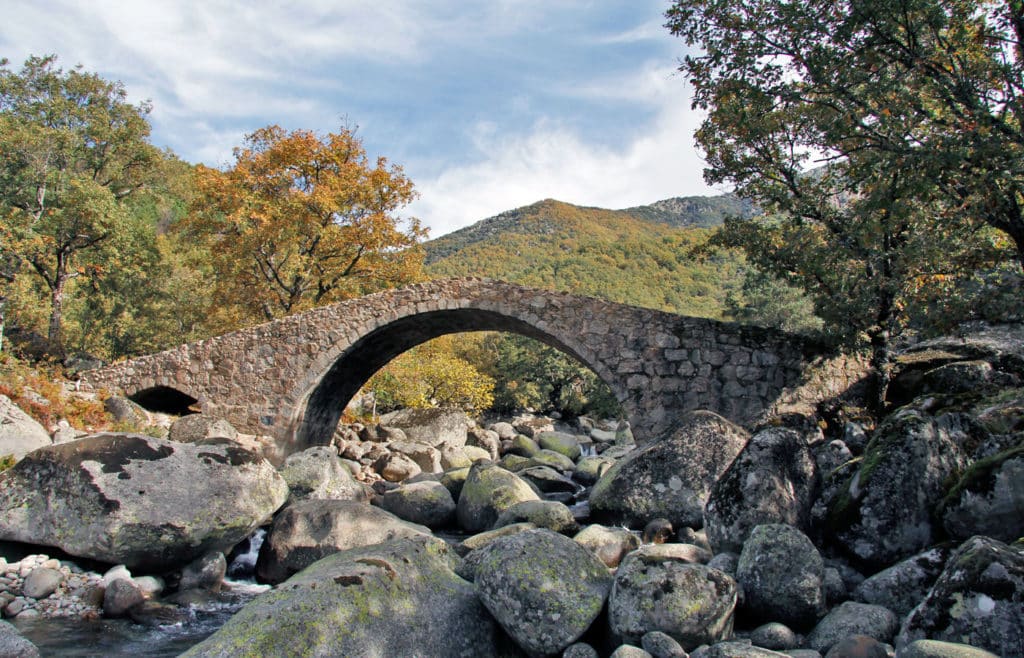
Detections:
[590, 411, 750, 528]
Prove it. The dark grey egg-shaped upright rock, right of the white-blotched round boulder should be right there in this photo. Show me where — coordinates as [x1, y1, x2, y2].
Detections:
[736, 524, 825, 630]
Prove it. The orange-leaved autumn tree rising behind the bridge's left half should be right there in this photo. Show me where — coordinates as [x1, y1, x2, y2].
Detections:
[188, 126, 426, 323]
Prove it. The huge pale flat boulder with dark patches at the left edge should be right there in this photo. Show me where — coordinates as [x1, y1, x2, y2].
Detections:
[0, 434, 288, 571]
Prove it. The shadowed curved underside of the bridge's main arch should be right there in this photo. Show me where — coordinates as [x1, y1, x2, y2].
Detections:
[292, 308, 627, 450]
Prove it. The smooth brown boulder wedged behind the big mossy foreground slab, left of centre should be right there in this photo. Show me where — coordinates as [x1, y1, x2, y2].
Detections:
[256, 500, 430, 583]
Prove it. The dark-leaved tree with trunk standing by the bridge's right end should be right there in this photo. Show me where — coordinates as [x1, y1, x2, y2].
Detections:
[667, 0, 1024, 407]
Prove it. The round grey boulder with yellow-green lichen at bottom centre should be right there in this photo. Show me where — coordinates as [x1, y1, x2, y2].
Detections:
[475, 529, 611, 656]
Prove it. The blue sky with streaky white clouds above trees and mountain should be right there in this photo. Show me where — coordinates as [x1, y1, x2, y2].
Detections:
[0, 0, 724, 237]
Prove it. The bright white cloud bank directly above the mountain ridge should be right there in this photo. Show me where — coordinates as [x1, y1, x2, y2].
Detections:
[410, 69, 720, 237]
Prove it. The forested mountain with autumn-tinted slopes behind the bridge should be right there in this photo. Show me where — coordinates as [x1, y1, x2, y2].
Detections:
[425, 195, 753, 317]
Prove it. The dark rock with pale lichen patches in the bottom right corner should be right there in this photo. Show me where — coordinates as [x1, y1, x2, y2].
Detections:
[896, 537, 1024, 658]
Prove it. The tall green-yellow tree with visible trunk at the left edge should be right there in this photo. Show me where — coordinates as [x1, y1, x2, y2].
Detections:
[0, 55, 156, 356]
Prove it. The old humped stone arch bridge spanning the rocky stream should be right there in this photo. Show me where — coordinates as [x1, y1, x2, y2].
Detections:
[83, 278, 839, 453]
